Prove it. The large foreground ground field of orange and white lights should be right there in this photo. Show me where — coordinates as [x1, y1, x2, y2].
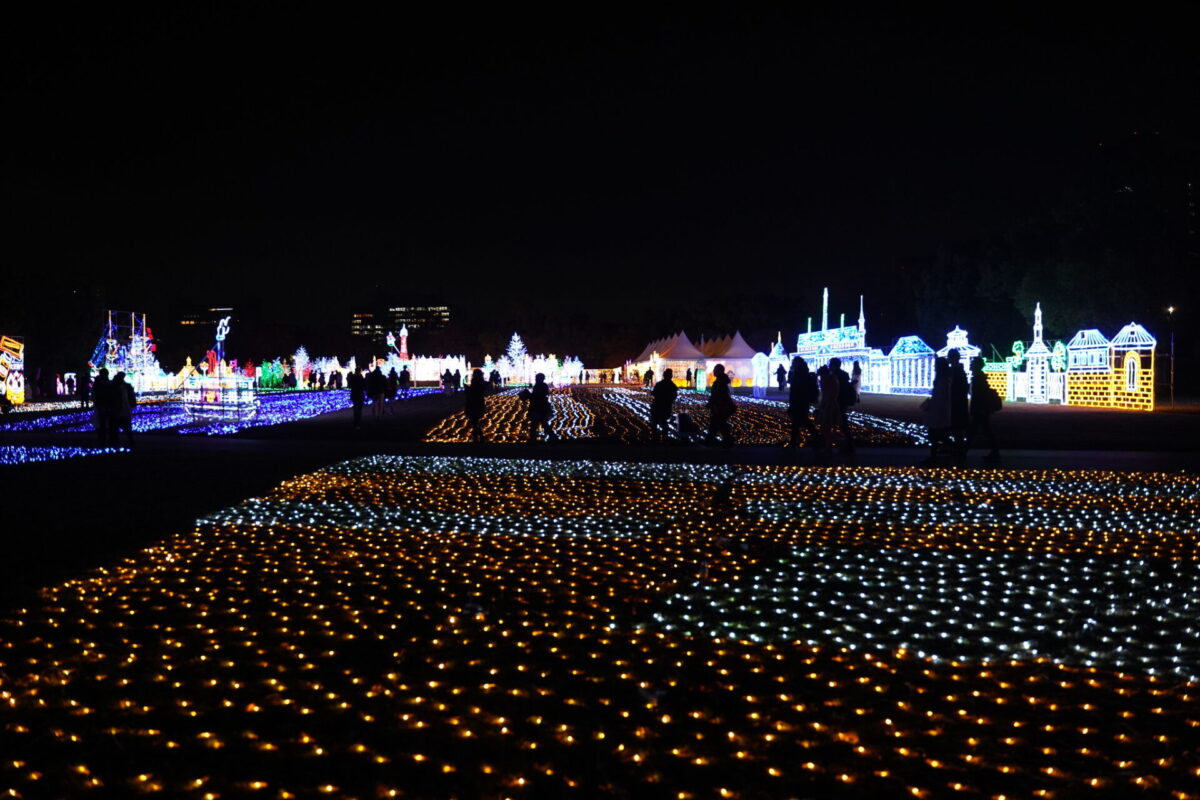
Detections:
[0, 456, 1200, 798]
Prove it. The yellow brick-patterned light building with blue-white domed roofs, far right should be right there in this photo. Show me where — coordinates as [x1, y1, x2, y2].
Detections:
[1067, 323, 1157, 411]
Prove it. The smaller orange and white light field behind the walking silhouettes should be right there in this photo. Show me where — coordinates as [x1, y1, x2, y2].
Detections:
[425, 386, 928, 446]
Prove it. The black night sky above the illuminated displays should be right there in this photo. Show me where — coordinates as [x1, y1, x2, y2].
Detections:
[0, 4, 1200, 369]
